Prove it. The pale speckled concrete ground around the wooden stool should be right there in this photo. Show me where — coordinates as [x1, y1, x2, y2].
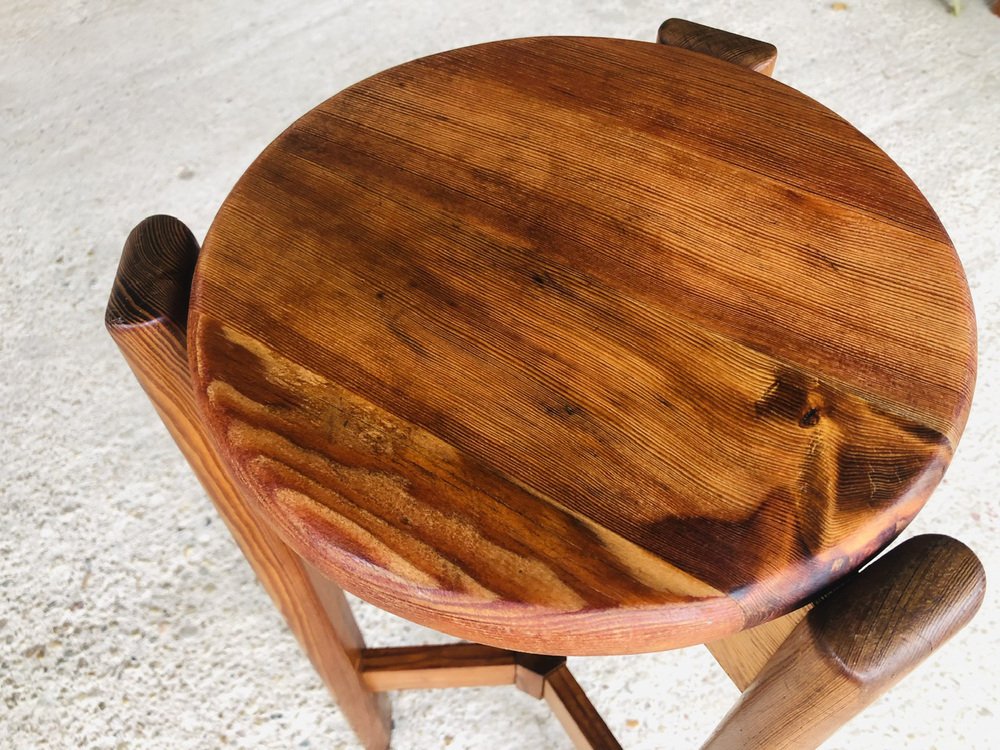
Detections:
[0, 0, 1000, 750]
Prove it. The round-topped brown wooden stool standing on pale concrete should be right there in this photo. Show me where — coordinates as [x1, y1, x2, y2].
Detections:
[107, 20, 985, 748]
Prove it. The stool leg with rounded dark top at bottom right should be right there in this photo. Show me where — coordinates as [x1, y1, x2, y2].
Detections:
[704, 535, 986, 750]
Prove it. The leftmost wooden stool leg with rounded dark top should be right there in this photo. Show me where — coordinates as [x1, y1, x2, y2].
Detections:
[105, 216, 391, 750]
